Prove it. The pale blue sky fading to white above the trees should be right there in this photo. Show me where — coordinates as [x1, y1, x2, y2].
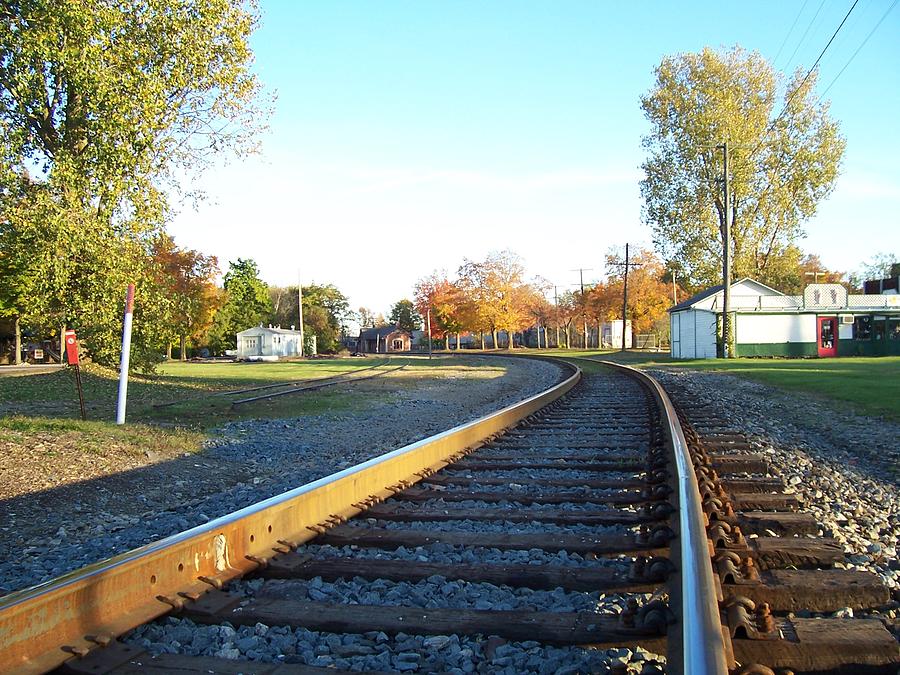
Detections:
[171, 0, 900, 312]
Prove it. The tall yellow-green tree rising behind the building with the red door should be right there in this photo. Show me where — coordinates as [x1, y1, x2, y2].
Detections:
[641, 47, 845, 289]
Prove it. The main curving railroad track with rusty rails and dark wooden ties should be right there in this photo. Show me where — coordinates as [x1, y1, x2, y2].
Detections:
[0, 356, 900, 674]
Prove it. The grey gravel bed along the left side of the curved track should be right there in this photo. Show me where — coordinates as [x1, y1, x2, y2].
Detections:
[0, 356, 563, 595]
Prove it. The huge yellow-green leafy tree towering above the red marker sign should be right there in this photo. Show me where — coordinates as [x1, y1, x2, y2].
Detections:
[0, 0, 264, 368]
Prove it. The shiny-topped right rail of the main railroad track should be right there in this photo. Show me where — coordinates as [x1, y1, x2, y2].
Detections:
[596, 357, 728, 675]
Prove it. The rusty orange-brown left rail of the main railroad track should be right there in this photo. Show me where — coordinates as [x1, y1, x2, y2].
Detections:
[0, 361, 581, 673]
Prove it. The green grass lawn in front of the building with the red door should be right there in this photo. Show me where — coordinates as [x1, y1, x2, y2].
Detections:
[543, 349, 900, 422]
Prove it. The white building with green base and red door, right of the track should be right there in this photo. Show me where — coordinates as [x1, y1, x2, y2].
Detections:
[669, 278, 900, 359]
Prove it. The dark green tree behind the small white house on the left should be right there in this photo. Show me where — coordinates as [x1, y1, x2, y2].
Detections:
[210, 258, 272, 352]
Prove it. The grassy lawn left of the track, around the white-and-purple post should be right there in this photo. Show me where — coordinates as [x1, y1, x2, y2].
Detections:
[0, 356, 503, 448]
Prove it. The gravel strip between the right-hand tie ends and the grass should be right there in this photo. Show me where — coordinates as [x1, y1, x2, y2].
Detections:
[648, 369, 900, 639]
